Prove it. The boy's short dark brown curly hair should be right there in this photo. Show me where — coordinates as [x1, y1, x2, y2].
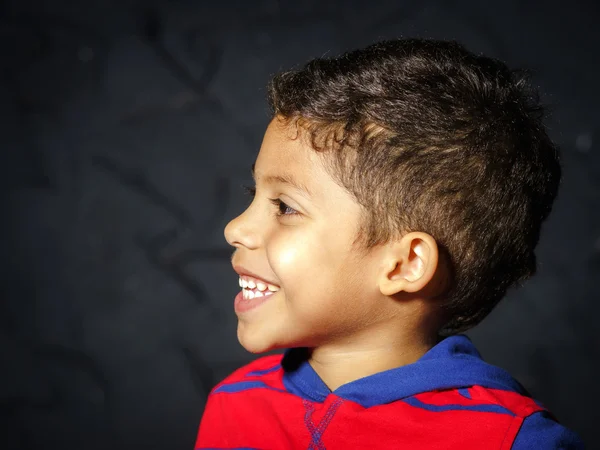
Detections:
[268, 39, 561, 335]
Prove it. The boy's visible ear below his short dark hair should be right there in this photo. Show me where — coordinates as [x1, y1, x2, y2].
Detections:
[379, 232, 439, 296]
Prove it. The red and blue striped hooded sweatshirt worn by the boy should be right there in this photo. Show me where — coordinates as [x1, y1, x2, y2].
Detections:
[195, 335, 583, 450]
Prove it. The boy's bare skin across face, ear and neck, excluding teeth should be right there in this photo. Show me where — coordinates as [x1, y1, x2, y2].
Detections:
[225, 119, 446, 390]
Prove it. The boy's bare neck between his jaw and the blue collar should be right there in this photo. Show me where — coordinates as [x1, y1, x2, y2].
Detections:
[309, 328, 438, 391]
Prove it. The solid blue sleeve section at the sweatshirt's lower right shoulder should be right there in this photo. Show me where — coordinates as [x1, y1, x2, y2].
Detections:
[511, 411, 584, 450]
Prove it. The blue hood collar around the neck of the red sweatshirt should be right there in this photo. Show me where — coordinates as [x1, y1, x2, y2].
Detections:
[282, 335, 528, 408]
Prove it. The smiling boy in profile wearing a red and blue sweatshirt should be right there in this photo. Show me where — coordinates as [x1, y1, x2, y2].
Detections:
[196, 39, 581, 450]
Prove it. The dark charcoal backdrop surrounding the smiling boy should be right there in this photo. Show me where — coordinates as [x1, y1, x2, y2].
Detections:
[0, 0, 600, 450]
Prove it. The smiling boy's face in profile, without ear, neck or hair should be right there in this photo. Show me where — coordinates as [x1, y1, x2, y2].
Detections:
[225, 120, 383, 352]
